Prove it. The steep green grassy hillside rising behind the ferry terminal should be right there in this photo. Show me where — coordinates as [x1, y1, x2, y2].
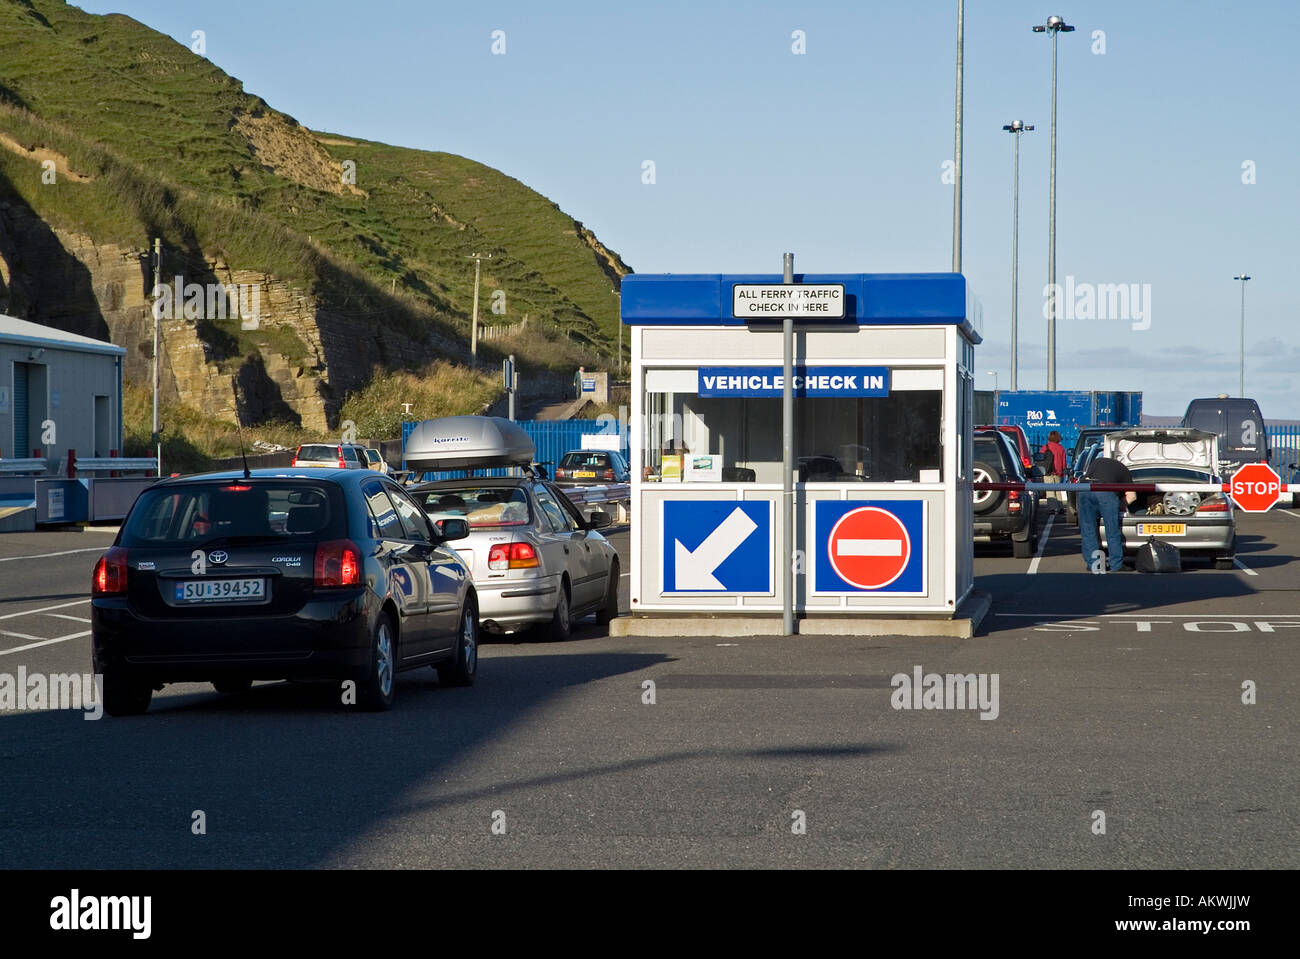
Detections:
[0, 0, 629, 426]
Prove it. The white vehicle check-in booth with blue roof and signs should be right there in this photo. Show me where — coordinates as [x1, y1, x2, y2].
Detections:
[621, 273, 980, 619]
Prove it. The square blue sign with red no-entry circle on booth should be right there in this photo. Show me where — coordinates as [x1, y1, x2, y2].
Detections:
[814, 500, 926, 595]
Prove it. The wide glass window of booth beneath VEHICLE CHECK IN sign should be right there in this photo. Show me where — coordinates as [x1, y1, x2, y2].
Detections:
[641, 369, 944, 483]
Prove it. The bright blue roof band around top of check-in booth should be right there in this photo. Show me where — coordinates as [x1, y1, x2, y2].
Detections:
[620, 273, 982, 343]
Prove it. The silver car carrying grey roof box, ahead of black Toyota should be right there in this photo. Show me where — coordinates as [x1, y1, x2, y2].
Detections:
[408, 477, 620, 641]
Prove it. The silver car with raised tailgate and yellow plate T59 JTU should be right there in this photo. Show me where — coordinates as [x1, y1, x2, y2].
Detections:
[1101, 426, 1236, 569]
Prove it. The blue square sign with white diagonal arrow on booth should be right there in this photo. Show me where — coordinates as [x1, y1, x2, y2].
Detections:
[659, 499, 772, 595]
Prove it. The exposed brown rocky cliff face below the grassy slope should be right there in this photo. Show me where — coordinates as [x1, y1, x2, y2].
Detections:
[0, 203, 447, 433]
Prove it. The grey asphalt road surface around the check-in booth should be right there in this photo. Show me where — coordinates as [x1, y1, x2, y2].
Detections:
[0, 511, 1300, 868]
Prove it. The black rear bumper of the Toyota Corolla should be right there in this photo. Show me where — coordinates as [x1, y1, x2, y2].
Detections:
[91, 593, 373, 684]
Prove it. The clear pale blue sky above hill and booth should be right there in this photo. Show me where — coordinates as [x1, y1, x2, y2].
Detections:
[79, 0, 1300, 418]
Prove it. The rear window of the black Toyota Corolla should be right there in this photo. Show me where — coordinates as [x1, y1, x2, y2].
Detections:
[121, 480, 347, 547]
